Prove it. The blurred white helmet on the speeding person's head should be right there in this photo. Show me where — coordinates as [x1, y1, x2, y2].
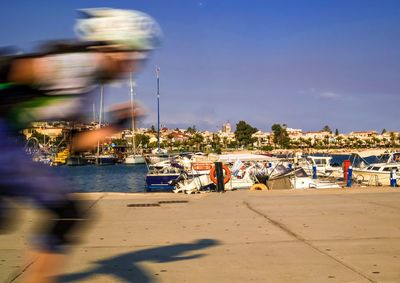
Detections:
[75, 8, 161, 51]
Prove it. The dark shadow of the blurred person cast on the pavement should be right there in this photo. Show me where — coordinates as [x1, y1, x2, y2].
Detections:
[57, 239, 219, 283]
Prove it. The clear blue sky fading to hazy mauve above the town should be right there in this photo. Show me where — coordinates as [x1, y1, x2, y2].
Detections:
[0, 0, 400, 132]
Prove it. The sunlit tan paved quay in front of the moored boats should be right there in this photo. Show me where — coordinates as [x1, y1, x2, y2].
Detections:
[0, 187, 400, 283]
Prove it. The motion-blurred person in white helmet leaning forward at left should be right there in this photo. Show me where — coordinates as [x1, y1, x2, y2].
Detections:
[0, 8, 160, 283]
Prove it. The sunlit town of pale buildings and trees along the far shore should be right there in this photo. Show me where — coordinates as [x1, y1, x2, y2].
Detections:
[24, 121, 400, 155]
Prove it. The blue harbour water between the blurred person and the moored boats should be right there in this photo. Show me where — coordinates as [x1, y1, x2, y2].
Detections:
[51, 164, 147, 192]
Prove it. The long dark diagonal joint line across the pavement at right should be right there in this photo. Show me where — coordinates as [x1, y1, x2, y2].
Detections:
[244, 201, 378, 283]
